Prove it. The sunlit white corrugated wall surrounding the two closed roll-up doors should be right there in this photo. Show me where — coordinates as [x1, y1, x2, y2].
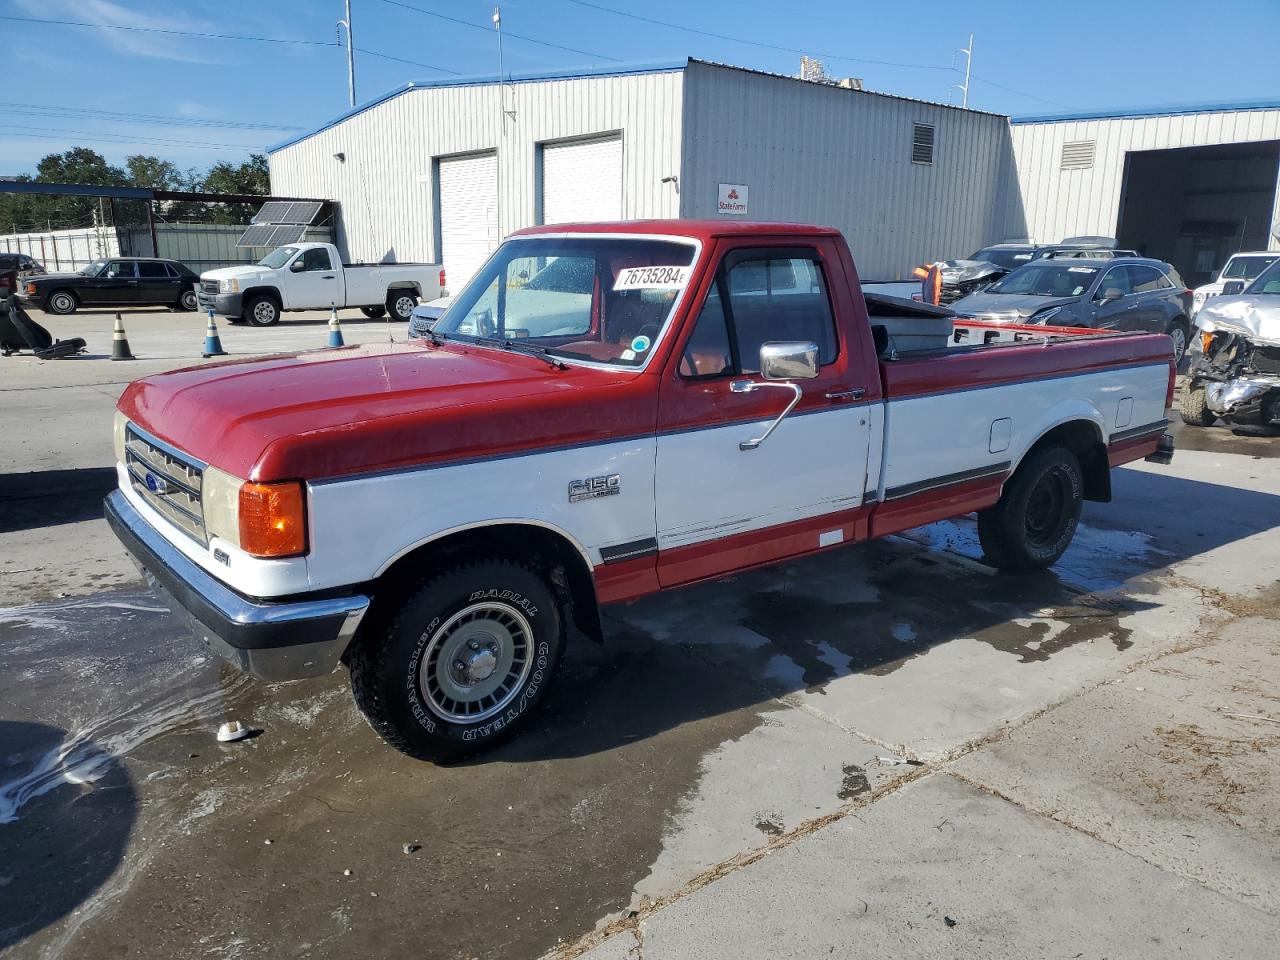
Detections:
[270, 70, 684, 262]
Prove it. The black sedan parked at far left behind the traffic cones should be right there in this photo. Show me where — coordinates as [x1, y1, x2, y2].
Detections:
[18, 257, 200, 314]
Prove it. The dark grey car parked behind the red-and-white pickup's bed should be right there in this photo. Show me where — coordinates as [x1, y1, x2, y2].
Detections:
[951, 257, 1192, 360]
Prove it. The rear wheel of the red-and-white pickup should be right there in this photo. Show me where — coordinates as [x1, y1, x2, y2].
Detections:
[978, 447, 1084, 573]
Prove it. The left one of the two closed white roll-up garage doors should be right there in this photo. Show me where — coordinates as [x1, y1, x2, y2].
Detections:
[440, 154, 498, 293]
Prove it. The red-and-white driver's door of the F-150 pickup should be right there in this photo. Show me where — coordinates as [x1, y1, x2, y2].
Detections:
[655, 238, 878, 586]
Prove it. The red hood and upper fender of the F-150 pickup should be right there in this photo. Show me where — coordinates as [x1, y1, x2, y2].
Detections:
[119, 340, 645, 481]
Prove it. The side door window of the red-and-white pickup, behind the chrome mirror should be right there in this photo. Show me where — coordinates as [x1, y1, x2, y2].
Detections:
[681, 255, 837, 376]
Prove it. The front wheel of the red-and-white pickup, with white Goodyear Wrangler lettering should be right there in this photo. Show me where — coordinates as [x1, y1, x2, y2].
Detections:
[349, 561, 563, 760]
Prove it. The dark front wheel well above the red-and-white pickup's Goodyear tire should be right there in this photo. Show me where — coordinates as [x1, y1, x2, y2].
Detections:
[374, 520, 603, 641]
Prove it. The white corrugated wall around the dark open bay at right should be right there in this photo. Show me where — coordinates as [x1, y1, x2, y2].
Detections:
[1005, 110, 1280, 244]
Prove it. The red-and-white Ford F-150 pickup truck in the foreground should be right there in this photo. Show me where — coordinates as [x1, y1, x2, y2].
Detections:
[106, 220, 1174, 758]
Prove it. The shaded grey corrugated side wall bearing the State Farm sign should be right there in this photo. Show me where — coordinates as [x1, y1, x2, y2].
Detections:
[681, 61, 1011, 279]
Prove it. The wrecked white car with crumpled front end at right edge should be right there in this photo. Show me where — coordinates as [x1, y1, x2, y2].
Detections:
[1181, 261, 1280, 426]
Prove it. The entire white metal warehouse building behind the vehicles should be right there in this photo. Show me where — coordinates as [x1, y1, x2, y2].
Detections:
[269, 60, 1280, 289]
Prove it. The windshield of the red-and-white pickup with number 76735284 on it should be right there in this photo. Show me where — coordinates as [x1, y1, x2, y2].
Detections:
[434, 237, 696, 367]
